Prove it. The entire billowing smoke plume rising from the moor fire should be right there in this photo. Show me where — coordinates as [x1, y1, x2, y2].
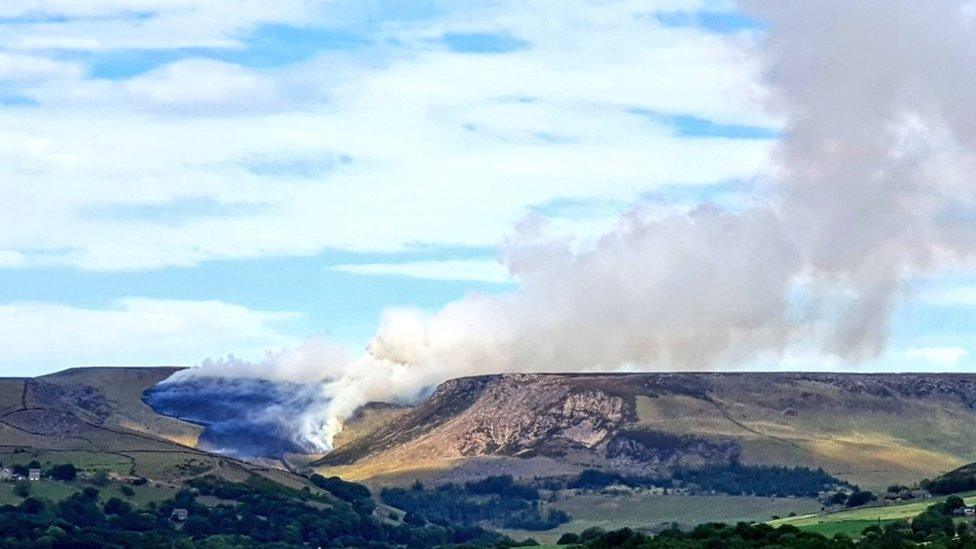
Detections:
[172, 0, 976, 449]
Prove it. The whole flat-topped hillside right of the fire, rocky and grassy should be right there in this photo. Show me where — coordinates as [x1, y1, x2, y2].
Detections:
[314, 373, 976, 487]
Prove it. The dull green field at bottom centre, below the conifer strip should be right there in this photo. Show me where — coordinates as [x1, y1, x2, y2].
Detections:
[500, 493, 820, 543]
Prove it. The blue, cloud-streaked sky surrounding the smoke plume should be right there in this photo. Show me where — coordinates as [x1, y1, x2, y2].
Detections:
[0, 0, 976, 375]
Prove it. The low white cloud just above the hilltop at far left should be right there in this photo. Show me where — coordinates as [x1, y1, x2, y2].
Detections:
[0, 298, 300, 375]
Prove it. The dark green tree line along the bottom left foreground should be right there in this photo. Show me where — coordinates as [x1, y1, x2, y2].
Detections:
[0, 470, 532, 549]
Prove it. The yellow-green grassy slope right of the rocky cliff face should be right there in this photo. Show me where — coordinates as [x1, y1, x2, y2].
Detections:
[636, 382, 976, 489]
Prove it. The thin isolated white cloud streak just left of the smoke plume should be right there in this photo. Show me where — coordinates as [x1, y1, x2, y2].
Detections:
[329, 259, 515, 284]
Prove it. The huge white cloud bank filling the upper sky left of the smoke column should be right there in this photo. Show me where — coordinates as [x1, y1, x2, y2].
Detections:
[0, 2, 770, 270]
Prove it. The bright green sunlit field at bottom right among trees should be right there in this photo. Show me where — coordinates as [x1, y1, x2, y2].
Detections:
[769, 494, 976, 535]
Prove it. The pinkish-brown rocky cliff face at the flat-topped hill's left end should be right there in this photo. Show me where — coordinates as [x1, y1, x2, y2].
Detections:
[324, 374, 634, 464]
